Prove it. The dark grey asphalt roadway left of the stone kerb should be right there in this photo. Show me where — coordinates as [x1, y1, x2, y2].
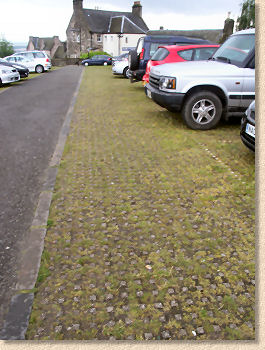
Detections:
[0, 66, 82, 328]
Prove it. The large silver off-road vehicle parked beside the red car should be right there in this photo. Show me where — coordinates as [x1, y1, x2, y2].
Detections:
[145, 29, 255, 130]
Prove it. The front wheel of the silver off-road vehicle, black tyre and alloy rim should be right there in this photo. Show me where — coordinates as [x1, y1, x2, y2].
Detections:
[182, 91, 222, 130]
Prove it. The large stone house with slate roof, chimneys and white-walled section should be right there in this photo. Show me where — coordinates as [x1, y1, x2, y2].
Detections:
[66, 0, 148, 58]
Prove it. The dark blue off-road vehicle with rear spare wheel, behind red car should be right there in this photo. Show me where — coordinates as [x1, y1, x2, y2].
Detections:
[129, 35, 213, 82]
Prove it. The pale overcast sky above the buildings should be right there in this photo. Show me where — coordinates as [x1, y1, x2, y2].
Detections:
[0, 0, 243, 42]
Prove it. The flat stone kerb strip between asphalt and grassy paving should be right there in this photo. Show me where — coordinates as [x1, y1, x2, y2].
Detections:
[0, 69, 84, 340]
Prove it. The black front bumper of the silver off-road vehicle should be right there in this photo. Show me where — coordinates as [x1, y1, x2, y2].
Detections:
[145, 83, 185, 112]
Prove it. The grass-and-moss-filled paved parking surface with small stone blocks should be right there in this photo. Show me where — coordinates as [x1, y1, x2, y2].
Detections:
[27, 67, 255, 340]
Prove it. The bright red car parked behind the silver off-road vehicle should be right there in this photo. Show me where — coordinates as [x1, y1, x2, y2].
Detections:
[143, 45, 220, 83]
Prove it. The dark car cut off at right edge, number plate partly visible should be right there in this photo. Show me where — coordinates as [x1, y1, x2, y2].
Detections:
[240, 101, 255, 152]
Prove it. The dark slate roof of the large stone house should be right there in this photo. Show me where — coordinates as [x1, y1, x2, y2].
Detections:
[84, 9, 148, 34]
